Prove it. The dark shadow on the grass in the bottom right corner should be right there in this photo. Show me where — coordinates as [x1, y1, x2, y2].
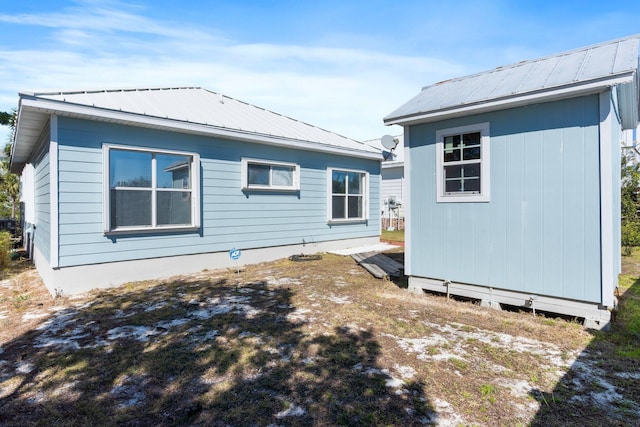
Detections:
[531, 279, 640, 427]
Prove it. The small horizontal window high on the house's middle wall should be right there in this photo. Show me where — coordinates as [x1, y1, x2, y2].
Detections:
[242, 158, 300, 191]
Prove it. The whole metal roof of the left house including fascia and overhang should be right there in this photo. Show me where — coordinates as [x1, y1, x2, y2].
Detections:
[12, 87, 380, 171]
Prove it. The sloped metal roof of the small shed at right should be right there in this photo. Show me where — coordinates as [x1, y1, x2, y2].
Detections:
[384, 34, 640, 128]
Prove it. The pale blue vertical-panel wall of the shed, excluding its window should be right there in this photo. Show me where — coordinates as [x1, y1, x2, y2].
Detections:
[408, 96, 604, 302]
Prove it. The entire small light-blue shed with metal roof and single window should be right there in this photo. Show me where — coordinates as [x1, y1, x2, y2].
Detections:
[384, 35, 640, 328]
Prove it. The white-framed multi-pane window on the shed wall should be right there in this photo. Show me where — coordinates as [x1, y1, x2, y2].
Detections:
[436, 123, 489, 202]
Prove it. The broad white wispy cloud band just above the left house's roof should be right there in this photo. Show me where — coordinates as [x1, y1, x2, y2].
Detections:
[0, 2, 464, 139]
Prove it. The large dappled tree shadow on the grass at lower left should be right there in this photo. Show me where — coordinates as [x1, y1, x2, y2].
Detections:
[0, 279, 436, 426]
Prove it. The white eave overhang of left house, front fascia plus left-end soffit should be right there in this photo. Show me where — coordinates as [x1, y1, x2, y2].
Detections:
[10, 94, 381, 173]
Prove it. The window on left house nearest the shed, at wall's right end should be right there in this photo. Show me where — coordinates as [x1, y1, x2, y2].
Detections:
[328, 169, 369, 221]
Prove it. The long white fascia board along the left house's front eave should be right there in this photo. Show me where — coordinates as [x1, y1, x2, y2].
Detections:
[23, 98, 380, 160]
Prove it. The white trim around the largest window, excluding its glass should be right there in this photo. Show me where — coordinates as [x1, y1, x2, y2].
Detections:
[102, 144, 200, 234]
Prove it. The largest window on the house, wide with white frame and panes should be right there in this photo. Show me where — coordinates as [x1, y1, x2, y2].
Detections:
[104, 145, 200, 232]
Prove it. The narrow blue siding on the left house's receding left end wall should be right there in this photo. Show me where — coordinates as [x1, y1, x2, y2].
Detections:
[33, 143, 51, 263]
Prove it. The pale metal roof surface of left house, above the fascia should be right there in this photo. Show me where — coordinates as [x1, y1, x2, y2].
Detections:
[28, 87, 374, 153]
